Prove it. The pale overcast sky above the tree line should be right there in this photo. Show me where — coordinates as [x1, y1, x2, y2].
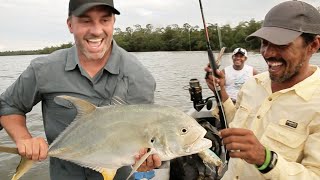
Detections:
[0, 0, 320, 51]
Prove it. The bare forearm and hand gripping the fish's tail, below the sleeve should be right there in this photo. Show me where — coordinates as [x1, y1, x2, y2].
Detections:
[0, 115, 48, 161]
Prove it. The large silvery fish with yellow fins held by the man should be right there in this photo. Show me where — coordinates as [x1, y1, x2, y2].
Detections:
[0, 96, 212, 179]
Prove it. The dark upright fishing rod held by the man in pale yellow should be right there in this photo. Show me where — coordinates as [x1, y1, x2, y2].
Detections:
[199, 0, 229, 165]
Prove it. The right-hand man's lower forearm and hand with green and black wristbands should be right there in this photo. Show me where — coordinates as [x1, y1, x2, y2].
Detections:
[220, 128, 320, 180]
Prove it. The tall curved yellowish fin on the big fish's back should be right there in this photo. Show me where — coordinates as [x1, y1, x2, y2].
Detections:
[54, 95, 97, 116]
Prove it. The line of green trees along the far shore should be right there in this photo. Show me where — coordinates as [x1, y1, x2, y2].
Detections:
[0, 19, 262, 56]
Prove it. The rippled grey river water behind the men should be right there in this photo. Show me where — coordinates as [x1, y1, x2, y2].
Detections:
[0, 51, 320, 180]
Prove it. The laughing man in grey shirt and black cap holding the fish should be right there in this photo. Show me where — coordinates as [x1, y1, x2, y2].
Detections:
[0, 0, 161, 180]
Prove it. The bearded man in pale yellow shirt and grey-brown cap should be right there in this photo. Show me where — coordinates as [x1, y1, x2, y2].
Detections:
[206, 1, 320, 180]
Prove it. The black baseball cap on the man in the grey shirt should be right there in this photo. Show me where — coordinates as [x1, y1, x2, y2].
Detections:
[69, 0, 120, 16]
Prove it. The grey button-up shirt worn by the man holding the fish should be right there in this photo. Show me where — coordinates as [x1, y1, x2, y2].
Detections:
[0, 41, 156, 180]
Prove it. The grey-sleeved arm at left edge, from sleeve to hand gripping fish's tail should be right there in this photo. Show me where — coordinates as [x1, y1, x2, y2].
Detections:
[0, 64, 48, 160]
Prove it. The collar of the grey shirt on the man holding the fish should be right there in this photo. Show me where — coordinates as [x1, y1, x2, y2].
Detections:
[65, 40, 120, 74]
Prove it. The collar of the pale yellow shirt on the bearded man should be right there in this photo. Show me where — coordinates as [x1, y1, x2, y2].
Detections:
[254, 65, 320, 101]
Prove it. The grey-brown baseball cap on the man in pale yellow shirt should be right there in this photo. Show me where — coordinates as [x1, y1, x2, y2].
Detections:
[246, 1, 320, 45]
